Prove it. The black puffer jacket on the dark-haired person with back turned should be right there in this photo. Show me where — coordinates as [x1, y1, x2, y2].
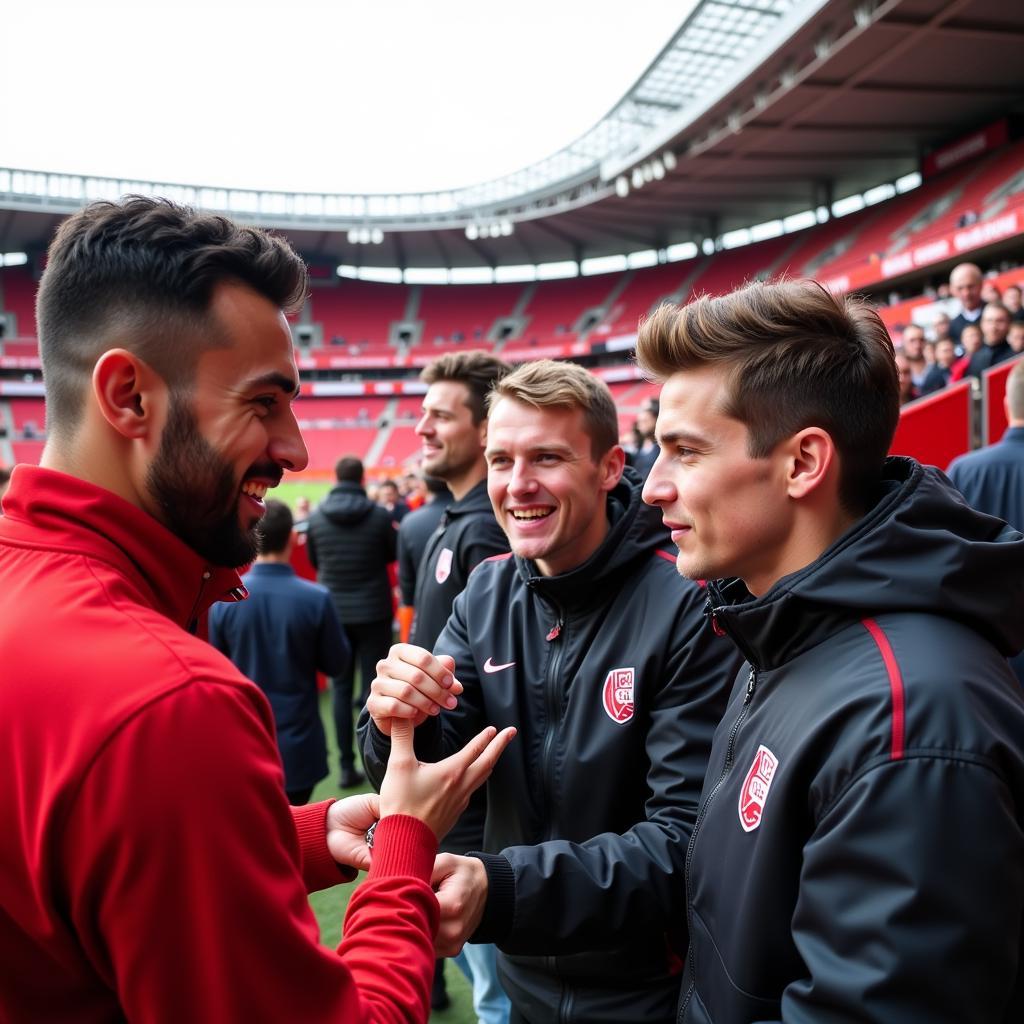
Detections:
[306, 480, 398, 625]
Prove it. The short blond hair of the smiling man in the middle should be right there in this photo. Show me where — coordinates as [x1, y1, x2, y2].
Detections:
[487, 359, 618, 462]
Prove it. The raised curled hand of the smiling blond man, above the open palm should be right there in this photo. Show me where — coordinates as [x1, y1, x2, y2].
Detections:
[367, 643, 462, 736]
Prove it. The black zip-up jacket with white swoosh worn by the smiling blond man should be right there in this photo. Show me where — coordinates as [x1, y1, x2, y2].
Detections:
[365, 469, 740, 1024]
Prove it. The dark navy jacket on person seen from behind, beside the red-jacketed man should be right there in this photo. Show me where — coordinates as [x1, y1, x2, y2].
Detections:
[210, 562, 350, 791]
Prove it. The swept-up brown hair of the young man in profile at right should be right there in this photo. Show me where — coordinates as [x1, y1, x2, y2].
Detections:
[637, 281, 899, 514]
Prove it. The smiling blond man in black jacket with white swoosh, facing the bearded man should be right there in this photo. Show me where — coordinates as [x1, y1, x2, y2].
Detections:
[364, 360, 739, 1024]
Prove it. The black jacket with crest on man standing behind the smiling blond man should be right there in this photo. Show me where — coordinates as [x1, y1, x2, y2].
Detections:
[410, 477, 509, 650]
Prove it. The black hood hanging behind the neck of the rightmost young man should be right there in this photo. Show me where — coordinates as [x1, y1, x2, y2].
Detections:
[709, 458, 1024, 669]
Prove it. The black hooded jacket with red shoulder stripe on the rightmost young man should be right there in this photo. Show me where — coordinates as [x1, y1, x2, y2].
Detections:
[679, 459, 1024, 1024]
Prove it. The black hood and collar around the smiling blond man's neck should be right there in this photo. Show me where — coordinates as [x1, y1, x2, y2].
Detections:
[515, 466, 675, 605]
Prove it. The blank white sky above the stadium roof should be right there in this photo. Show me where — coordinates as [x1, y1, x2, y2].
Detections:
[0, 0, 695, 193]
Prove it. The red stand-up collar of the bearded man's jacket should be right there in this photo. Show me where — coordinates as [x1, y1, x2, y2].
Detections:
[0, 465, 245, 629]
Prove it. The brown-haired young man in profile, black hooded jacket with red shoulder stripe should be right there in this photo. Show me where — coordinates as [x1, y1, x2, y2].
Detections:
[637, 282, 1024, 1024]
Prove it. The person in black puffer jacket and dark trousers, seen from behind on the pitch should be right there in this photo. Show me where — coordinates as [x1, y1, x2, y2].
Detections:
[306, 456, 396, 790]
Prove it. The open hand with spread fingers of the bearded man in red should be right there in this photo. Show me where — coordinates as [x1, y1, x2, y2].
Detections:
[380, 718, 516, 839]
